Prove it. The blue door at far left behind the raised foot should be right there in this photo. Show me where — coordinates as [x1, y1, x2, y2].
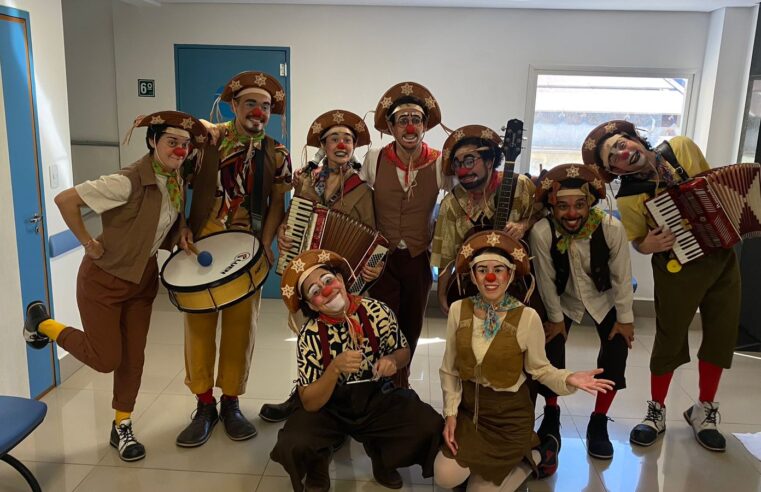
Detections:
[0, 7, 58, 397]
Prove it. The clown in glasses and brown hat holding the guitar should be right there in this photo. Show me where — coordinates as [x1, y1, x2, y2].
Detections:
[431, 125, 542, 314]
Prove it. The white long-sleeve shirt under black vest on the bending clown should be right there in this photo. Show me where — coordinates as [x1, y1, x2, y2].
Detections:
[529, 214, 634, 323]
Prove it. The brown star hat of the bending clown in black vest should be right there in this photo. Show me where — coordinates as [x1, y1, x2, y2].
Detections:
[535, 164, 605, 206]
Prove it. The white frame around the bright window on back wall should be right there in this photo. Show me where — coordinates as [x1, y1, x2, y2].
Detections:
[517, 65, 699, 173]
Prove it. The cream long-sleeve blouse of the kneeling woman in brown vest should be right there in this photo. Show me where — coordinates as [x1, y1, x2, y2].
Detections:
[439, 301, 576, 417]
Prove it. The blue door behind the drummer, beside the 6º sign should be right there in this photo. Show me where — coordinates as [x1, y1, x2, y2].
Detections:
[174, 44, 291, 298]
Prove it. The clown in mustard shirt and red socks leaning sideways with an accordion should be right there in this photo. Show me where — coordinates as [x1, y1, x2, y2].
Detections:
[582, 120, 740, 451]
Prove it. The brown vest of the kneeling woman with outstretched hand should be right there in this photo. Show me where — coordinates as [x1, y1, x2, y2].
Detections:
[455, 298, 523, 388]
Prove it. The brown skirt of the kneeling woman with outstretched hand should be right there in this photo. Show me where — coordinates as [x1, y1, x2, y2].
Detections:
[441, 381, 539, 485]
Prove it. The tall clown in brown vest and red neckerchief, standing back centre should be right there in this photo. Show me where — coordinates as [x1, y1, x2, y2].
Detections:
[360, 82, 452, 387]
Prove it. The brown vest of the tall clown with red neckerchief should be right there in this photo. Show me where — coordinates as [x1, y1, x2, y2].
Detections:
[368, 150, 439, 257]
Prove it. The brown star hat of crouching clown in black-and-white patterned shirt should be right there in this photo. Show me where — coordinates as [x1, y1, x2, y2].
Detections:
[280, 249, 355, 313]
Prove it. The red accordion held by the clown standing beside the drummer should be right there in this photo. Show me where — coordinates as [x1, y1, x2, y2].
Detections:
[276, 196, 388, 294]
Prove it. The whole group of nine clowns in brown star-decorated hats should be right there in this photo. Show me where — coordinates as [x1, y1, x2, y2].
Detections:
[23, 72, 740, 491]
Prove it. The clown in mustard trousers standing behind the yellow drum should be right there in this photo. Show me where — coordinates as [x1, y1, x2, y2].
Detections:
[176, 71, 291, 447]
